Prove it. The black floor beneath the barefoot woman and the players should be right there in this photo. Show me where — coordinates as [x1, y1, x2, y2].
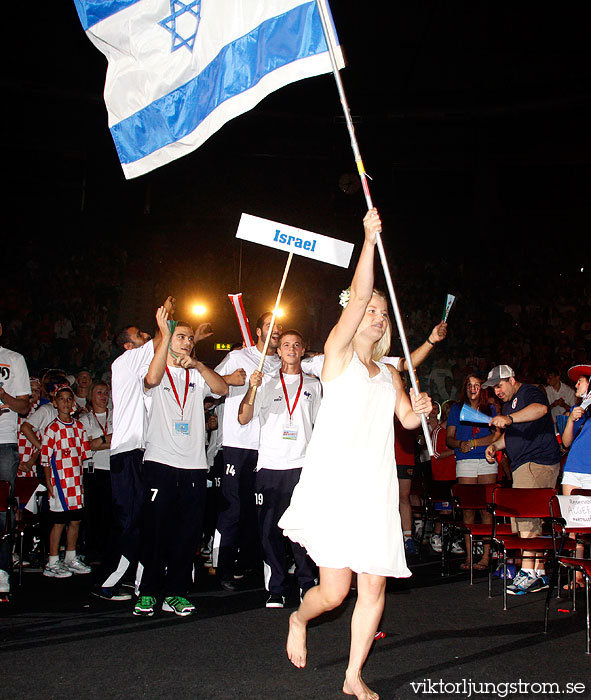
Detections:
[0, 560, 591, 700]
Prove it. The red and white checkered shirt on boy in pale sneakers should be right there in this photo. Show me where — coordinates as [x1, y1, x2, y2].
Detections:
[41, 418, 91, 512]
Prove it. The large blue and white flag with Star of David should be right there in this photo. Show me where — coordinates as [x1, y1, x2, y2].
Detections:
[74, 0, 343, 178]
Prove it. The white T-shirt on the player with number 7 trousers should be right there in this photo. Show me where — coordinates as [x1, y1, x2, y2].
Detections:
[144, 367, 211, 469]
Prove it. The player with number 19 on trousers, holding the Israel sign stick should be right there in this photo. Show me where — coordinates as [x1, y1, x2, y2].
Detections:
[238, 330, 321, 608]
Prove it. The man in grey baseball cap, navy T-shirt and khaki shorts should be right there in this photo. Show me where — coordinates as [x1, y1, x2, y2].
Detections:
[482, 365, 560, 595]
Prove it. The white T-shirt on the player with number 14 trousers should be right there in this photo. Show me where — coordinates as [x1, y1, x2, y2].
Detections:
[215, 345, 281, 450]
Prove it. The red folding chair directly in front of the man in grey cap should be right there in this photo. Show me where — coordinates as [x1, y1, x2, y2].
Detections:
[488, 488, 576, 610]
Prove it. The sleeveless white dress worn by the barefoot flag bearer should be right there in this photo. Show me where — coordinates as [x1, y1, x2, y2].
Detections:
[279, 354, 410, 578]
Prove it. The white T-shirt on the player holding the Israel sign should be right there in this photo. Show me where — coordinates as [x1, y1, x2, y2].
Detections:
[254, 374, 322, 471]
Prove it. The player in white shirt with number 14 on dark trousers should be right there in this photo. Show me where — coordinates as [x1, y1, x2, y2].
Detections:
[213, 313, 282, 590]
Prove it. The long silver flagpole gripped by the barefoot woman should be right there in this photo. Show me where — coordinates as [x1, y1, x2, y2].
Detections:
[316, 0, 434, 457]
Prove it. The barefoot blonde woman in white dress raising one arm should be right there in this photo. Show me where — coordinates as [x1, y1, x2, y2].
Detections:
[279, 209, 431, 700]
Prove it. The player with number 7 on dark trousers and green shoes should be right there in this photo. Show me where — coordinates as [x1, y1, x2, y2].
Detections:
[133, 307, 228, 616]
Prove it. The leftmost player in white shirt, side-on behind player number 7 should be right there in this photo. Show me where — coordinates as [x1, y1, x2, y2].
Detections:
[97, 297, 175, 600]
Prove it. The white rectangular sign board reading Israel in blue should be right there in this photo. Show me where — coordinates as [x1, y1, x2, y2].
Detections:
[236, 214, 353, 267]
